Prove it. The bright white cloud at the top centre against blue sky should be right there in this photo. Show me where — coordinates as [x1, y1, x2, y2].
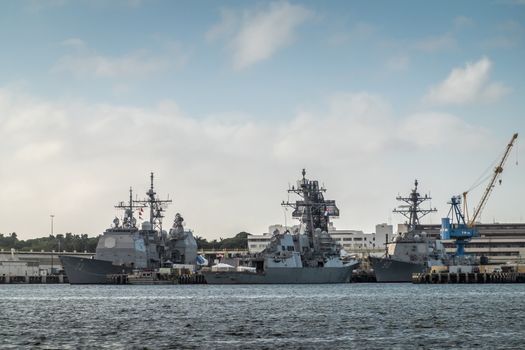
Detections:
[206, 2, 312, 69]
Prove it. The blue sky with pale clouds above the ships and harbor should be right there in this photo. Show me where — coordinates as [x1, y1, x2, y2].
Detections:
[0, 0, 525, 239]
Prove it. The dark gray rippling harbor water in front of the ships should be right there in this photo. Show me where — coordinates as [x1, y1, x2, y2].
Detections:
[0, 284, 525, 349]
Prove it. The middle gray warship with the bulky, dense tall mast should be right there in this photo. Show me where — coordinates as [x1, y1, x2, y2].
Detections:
[202, 169, 358, 284]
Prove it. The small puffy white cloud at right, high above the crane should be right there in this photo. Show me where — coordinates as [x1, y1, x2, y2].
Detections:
[424, 57, 510, 104]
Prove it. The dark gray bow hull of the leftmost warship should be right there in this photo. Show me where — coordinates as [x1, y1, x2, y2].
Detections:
[59, 256, 129, 284]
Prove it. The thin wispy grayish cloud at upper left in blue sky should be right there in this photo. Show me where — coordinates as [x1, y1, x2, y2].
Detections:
[52, 38, 187, 78]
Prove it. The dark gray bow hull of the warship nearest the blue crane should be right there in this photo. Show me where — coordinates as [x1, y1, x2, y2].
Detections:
[369, 256, 427, 282]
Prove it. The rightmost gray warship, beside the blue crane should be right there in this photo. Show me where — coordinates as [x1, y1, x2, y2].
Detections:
[369, 180, 444, 282]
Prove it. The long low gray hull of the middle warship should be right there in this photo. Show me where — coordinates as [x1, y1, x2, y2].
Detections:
[202, 264, 358, 284]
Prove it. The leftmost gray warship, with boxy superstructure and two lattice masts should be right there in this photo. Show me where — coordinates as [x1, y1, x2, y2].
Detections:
[60, 173, 197, 284]
